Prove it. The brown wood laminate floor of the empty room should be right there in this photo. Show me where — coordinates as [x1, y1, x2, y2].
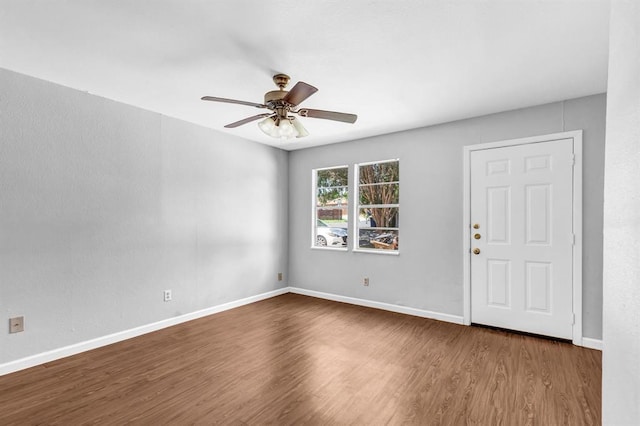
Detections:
[0, 294, 601, 426]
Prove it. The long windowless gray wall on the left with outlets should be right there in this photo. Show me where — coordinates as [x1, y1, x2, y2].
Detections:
[0, 69, 288, 364]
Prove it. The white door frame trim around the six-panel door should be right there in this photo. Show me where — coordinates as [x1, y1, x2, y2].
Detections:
[462, 130, 583, 346]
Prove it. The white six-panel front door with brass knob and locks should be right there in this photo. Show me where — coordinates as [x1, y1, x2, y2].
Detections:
[470, 139, 575, 339]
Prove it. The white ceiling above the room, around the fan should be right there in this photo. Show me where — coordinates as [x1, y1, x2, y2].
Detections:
[0, 0, 609, 150]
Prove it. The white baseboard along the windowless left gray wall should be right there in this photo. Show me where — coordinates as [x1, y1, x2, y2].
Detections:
[0, 287, 289, 376]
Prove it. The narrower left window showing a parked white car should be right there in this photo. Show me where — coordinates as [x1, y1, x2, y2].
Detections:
[312, 166, 349, 249]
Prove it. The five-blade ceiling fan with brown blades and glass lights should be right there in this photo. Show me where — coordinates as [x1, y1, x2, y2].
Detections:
[201, 74, 358, 139]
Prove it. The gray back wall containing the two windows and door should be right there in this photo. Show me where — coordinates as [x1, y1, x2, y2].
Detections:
[289, 95, 606, 339]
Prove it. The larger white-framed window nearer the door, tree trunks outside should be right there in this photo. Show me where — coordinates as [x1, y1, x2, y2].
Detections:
[355, 159, 400, 251]
